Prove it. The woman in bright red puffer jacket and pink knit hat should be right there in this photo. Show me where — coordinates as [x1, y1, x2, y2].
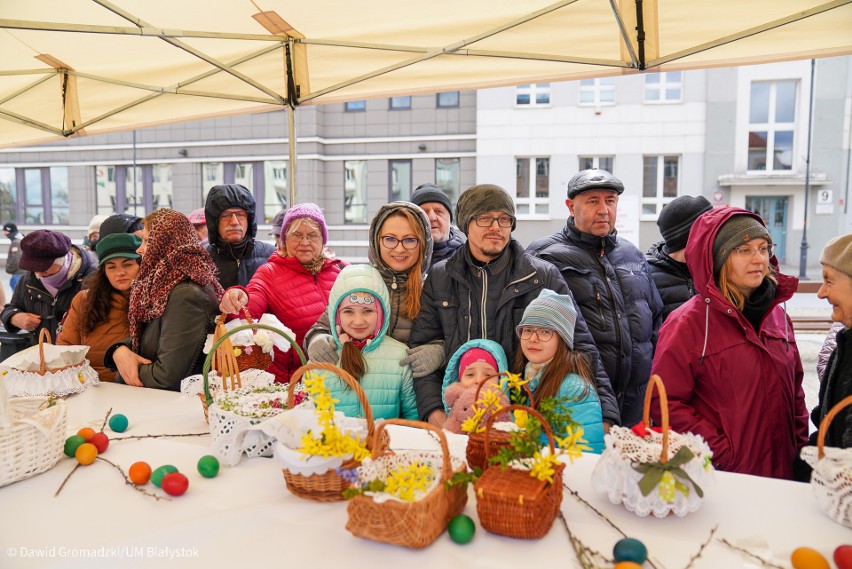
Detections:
[220, 203, 343, 383]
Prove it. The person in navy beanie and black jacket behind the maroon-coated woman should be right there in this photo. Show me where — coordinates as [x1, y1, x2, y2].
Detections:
[645, 196, 713, 321]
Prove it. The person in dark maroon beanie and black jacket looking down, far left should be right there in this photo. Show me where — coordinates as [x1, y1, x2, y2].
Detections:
[0, 229, 96, 339]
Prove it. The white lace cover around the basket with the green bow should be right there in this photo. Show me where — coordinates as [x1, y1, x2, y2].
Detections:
[592, 427, 716, 518]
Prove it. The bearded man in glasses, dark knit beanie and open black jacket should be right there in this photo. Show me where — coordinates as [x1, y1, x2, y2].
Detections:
[408, 184, 619, 425]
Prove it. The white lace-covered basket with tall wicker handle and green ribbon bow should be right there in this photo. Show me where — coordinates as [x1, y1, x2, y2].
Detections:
[592, 375, 715, 518]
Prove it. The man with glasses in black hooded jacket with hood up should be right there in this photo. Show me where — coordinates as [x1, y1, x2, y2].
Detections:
[204, 184, 275, 289]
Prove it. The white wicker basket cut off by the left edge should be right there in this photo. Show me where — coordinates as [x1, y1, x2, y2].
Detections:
[0, 381, 68, 486]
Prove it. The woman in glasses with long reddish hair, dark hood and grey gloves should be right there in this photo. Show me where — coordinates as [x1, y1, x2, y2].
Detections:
[305, 202, 444, 377]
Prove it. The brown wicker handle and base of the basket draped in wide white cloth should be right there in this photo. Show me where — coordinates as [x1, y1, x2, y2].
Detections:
[282, 362, 390, 502]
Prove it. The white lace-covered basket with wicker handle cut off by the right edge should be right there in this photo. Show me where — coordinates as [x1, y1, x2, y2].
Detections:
[801, 395, 852, 528]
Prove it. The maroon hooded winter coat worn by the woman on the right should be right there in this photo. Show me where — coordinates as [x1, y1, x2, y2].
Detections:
[651, 208, 808, 478]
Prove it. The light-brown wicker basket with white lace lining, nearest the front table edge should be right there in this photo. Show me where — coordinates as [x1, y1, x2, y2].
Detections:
[346, 419, 467, 549]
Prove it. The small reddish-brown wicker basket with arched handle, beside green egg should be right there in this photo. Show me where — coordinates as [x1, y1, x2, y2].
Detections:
[474, 405, 565, 539]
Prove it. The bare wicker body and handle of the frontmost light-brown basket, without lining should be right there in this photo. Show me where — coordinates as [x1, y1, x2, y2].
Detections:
[346, 419, 467, 549]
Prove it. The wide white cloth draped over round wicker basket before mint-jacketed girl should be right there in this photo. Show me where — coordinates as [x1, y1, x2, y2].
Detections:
[270, 403, 367, 476]
